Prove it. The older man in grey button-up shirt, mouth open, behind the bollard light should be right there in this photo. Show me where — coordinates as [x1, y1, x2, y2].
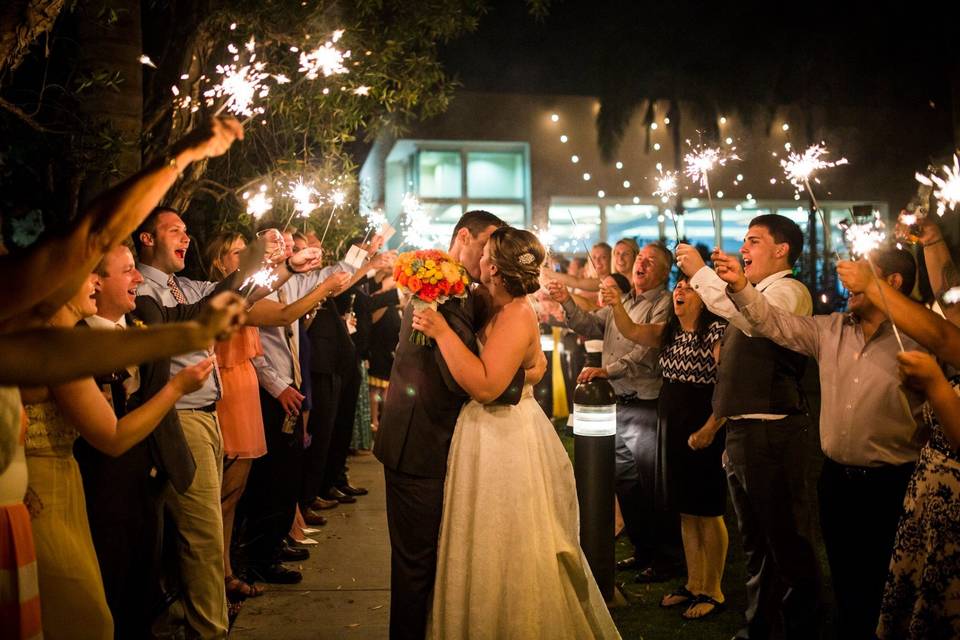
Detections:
[548, 244, 675, 582]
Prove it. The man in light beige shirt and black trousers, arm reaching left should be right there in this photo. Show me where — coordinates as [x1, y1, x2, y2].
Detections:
[713, 248, 927, 639]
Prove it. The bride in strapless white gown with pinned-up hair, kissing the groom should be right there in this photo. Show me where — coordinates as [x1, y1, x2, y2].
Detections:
[413, 227, 620, 640]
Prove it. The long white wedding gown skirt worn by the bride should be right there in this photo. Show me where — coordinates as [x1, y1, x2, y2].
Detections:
[427, 350, 620, 640]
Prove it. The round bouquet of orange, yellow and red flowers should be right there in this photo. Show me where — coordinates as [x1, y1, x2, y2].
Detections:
[393, 249, 470, 346]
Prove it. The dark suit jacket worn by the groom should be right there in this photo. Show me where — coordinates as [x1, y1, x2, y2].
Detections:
[373, 291, 524, 478]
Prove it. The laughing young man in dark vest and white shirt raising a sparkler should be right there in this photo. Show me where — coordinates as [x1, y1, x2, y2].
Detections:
[677, 214, 820, 640]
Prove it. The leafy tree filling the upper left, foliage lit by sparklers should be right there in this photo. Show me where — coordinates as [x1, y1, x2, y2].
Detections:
[0, 0, 496, 262]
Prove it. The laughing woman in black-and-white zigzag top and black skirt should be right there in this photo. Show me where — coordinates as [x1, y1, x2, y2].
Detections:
[601, 277, 728, 619]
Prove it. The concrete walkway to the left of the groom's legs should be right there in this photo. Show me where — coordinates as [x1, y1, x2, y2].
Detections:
[231, 455, 390, 640]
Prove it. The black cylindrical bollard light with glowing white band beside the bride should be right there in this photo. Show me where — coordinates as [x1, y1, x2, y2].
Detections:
[573, 350, 617, 602]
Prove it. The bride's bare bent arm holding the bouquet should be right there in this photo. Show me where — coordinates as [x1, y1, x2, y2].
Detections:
[413, 305, 536, 403]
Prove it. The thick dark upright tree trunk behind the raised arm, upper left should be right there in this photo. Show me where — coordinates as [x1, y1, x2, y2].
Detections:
[77, 0, 144, 201]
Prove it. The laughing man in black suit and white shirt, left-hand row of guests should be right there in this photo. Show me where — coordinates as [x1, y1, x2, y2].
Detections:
[74, 245, 244, 638]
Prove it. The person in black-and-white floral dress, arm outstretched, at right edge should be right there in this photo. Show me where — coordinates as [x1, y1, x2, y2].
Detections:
[837, 261, 960, 640]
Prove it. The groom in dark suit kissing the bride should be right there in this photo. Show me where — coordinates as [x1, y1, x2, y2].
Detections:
[373, 211, 546, 640]
